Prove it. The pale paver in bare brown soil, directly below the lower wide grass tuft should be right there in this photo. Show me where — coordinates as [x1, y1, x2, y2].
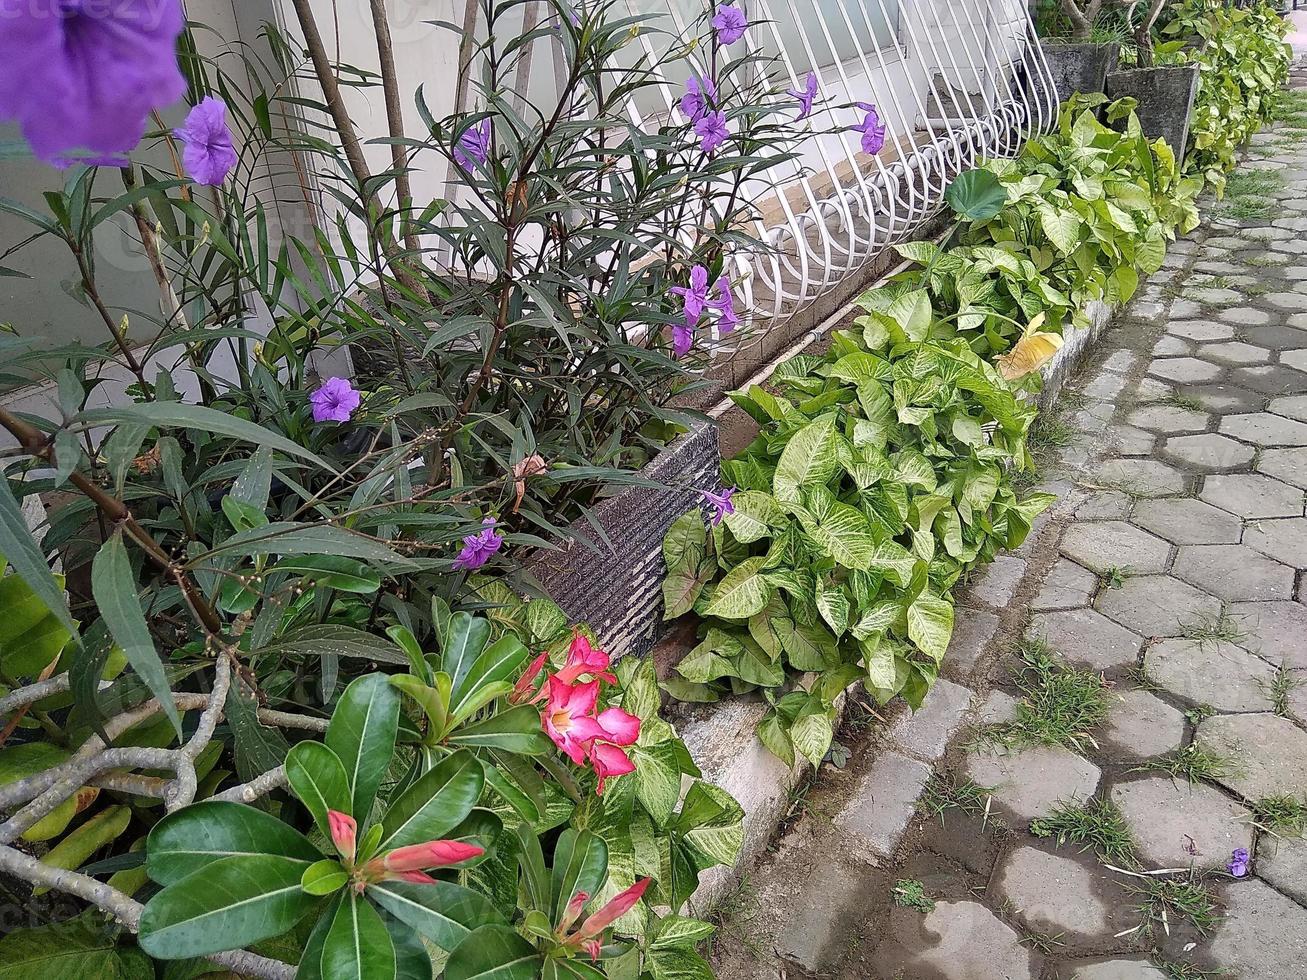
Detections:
[993, 847, 1133, 947]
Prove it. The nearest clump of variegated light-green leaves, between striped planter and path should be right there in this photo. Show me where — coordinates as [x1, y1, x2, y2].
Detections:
[664, 299, 1053, 766]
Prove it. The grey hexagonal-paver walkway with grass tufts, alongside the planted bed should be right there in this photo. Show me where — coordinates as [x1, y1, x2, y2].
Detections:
[715, 88, 1307, 980]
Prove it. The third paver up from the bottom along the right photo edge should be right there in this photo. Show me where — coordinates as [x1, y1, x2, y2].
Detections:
[1197, 713, 1307, 800]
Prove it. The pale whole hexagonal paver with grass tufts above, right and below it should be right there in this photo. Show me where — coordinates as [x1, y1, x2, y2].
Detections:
[1144, 640, 1276, 711]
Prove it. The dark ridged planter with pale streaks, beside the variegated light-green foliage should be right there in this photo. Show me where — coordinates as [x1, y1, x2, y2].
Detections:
[525, 422, 721, 657]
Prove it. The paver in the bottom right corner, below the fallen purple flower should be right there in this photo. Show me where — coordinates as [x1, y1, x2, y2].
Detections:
[1208, 878, 1307, 980]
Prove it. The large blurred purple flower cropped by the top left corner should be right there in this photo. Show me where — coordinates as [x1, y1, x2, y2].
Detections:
[0, 0, 186, 166]
